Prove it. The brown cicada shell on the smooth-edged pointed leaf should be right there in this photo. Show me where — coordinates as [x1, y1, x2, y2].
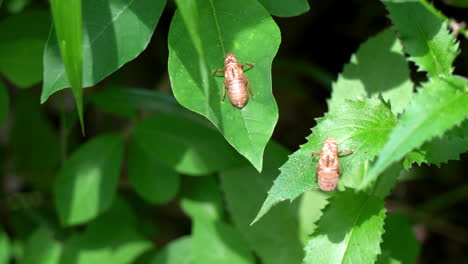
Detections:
[213, 53, 254, 109]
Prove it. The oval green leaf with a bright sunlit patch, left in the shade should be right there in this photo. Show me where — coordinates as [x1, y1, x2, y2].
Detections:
[54, 134, 123, 226]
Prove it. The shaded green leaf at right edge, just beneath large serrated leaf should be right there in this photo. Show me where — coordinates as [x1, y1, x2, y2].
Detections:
[403, 119, 468, 169]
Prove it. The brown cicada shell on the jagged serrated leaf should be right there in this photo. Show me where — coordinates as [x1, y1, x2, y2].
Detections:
[312, 137, 354, 192]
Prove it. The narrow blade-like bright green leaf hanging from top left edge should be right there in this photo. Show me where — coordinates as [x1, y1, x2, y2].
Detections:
[50, 0, 84, 130]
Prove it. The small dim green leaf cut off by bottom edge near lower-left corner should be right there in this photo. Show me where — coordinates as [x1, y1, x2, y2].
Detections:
[21, 227, 62, 264]
